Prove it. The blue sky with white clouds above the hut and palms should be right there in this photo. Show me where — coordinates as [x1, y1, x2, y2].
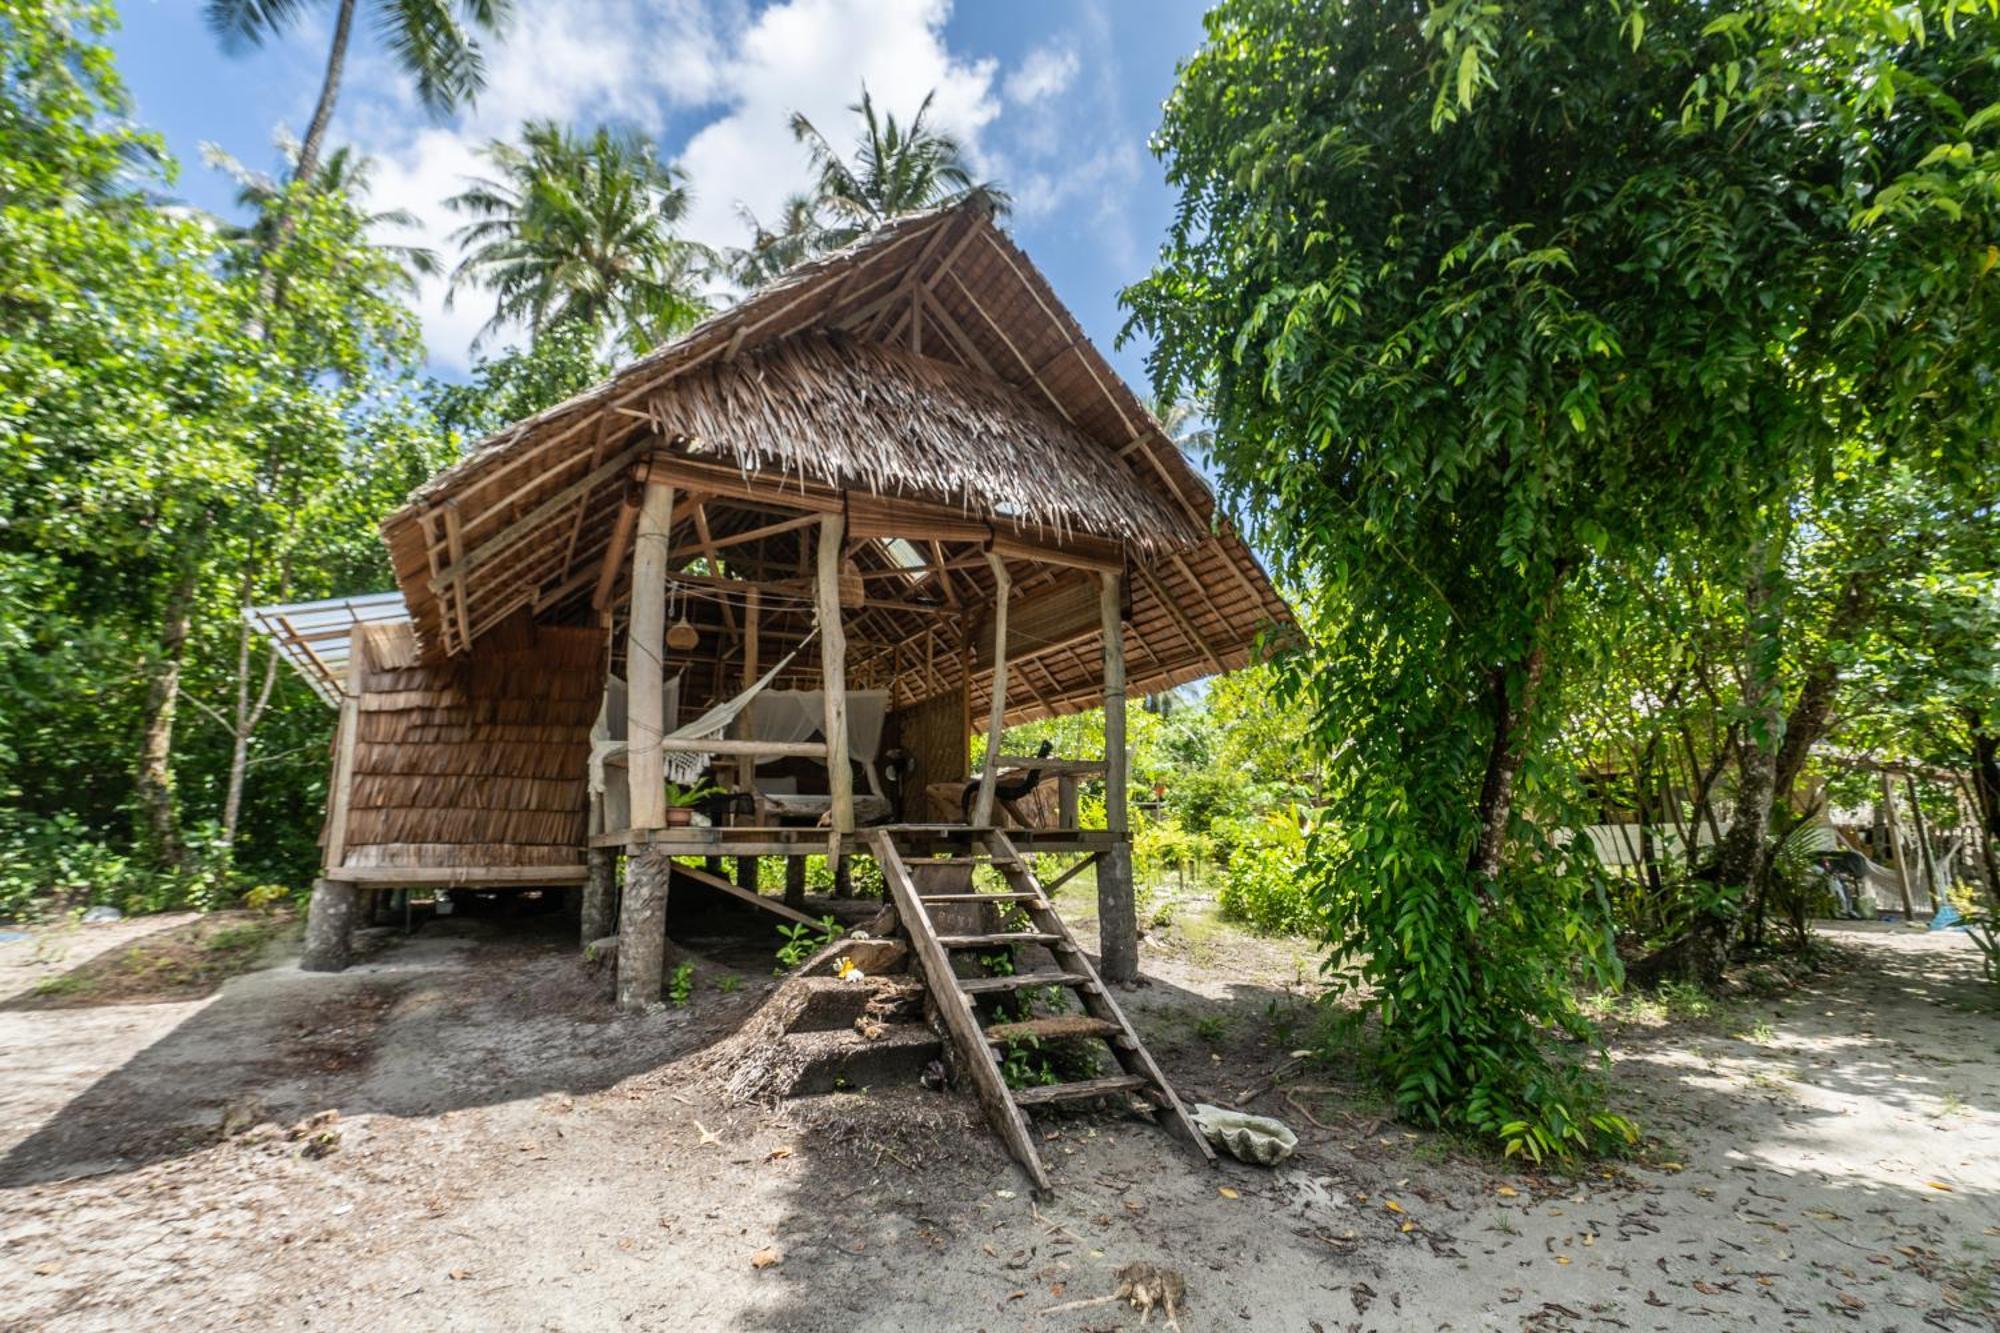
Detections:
[114, 0, 1204, 388]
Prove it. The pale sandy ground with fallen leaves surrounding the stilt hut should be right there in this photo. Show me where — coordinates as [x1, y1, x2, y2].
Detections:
[0, 895, 2000, 1333]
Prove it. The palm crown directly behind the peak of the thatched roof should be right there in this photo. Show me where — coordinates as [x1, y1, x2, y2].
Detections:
[792, 88, 1012, 248]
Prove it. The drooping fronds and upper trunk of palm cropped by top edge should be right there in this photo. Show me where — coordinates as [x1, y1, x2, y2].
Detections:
[206, 0, 514, 184]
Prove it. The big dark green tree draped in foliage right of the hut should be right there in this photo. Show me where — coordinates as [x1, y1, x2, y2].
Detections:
[1128, 0, 1992, 1151]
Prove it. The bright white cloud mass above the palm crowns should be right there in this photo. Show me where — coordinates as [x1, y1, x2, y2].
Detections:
[336, 0, 1000, 368]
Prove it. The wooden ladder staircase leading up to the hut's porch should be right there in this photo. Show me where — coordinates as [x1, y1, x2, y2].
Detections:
[866, 825, 1216, 1193]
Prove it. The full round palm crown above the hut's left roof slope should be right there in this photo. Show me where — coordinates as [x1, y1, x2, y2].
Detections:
[444, 120, 714, 352]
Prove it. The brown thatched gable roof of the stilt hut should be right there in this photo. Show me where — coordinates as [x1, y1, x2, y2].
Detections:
[384, 206, 1290, 717]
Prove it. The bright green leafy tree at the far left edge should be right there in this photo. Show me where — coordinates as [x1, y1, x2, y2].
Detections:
[0, 0, 282, 861]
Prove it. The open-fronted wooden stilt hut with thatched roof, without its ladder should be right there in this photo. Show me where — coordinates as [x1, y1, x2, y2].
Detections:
[260, 197, 1288, 1176]
